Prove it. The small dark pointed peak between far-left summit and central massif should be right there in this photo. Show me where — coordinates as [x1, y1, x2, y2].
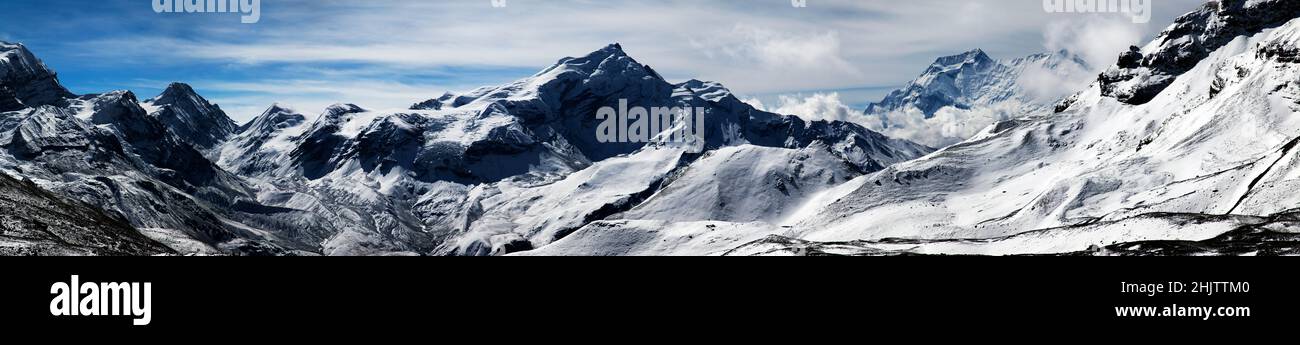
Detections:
[140, 83, 237, 152]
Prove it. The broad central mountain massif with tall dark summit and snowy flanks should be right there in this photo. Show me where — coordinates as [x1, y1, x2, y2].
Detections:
[218, 44, 932, 255]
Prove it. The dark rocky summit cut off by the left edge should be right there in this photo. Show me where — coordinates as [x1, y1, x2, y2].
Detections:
[0, 42, 73, 112]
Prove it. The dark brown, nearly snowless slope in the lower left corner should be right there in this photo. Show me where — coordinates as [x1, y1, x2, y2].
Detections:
[0, 173, 173, 255]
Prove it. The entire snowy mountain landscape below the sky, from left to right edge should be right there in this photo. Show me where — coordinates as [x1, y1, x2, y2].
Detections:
[0, 0, 1300, 255]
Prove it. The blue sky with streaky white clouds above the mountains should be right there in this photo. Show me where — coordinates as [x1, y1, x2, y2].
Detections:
[0, 0, 1203, 121]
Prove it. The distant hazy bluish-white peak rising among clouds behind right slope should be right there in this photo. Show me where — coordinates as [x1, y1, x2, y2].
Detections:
[866, 49, 1088, 117]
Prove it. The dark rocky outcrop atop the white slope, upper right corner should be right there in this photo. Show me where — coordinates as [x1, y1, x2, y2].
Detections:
[1099, 0, 1300, 104]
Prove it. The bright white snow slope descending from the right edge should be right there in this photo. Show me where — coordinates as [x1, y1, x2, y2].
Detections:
[769, 1, 1300, 254]
